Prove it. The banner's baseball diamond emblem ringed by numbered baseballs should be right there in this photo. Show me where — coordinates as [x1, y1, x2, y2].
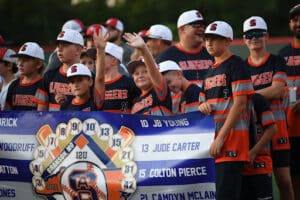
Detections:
[29, 118, 137, 200]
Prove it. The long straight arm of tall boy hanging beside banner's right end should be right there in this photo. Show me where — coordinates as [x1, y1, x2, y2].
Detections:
[210, 95, 247, 157]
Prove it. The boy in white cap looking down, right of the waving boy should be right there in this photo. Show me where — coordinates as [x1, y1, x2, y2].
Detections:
[159, 60, 201, 114]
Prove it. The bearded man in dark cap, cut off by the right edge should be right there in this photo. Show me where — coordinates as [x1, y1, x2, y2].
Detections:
[279, 4, 300, 199]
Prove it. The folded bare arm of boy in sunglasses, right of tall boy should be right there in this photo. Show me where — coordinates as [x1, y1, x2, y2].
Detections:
[255, 81, 285, 100]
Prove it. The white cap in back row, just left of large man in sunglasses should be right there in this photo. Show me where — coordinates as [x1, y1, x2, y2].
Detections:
[146, 24, 173, 41]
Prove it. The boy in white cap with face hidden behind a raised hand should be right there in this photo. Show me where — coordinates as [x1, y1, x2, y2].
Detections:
[94, 30, 140, 113]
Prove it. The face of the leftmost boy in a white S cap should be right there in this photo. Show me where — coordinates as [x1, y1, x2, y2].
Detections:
[18, 57, 42, 76]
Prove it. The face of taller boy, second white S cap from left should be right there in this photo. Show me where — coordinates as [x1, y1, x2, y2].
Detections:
[57, 41, 82, 64]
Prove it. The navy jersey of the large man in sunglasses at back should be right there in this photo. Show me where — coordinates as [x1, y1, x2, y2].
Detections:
[156, 44, 214, 87]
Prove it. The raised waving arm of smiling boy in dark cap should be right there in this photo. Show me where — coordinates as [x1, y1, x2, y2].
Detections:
[123, 33, 163, 88]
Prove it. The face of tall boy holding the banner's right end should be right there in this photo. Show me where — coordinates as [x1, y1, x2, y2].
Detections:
[205, 35, 228, 57]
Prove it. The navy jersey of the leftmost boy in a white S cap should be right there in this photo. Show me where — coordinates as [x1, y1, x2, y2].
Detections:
[5, 77, 42, 110]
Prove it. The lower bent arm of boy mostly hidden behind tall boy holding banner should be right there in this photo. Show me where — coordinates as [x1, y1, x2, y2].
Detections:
[250, 123, 277, 163]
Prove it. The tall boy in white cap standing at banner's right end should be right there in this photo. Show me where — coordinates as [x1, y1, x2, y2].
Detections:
[199, 21, 254, 200]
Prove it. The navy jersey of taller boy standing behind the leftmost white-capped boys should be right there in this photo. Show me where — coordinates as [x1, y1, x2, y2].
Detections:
[35, 67, 73, 111]
